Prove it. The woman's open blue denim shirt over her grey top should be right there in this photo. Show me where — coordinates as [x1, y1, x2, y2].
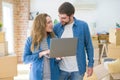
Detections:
[23, 37, 59, 80]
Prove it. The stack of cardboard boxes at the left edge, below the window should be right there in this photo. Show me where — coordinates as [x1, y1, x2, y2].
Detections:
[0, 32, 17, 80]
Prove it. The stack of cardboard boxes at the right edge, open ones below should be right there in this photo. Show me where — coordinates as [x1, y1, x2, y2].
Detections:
[94, 28, 120, 80]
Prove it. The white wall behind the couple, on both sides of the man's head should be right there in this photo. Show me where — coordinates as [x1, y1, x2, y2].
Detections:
[30, 0, 120, 34]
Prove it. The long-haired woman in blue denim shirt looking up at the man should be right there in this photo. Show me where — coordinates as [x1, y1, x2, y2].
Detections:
[23, 13, 59, 80]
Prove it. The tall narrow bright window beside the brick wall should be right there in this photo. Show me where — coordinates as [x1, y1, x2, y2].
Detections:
[2, 2, 14, 54]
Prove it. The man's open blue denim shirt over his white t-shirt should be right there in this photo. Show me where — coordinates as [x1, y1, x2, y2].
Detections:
[53, 18, 94, 74]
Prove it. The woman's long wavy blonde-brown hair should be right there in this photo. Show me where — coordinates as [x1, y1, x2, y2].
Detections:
[31, 13, 55, 52]
